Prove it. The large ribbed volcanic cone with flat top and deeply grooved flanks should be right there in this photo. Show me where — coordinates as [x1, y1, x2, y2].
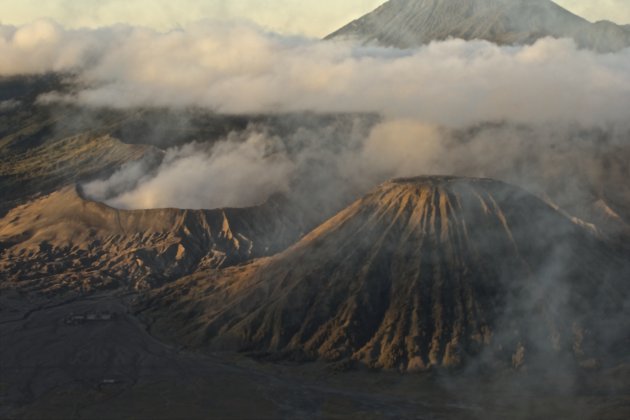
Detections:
[139, 177, 628, 371]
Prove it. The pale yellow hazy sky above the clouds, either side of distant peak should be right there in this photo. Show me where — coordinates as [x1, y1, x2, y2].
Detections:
[0, 0, 630, 37]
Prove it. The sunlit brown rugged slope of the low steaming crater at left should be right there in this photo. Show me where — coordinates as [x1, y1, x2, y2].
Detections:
[0, 187, 301, 292]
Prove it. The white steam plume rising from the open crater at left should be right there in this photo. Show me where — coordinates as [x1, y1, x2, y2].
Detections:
[83, 132, 294, 209]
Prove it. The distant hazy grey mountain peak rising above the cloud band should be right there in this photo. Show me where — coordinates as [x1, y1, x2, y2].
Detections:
[327, 0, 630, 52]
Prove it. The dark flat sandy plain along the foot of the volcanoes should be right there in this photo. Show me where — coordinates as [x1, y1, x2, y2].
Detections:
[0, 293, 630, 420]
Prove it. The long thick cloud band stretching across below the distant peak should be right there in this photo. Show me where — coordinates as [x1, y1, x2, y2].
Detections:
[0, 21, 630, 127]
